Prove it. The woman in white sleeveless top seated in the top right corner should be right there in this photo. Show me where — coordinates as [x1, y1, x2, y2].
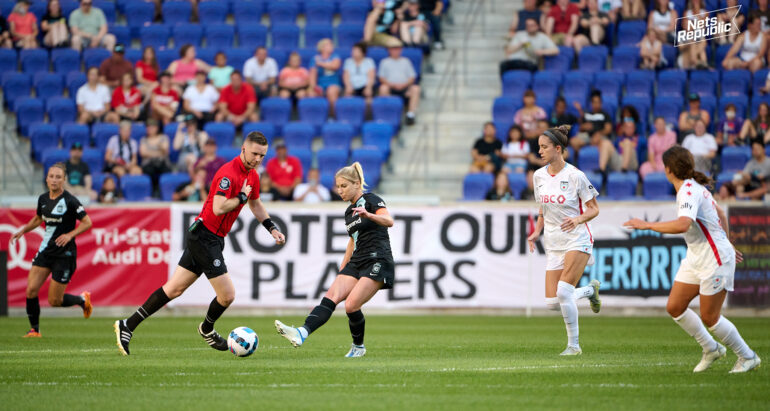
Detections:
[722, 13, 767, 73]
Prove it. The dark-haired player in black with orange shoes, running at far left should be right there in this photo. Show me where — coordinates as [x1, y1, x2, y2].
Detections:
[11, 163, 93, 337]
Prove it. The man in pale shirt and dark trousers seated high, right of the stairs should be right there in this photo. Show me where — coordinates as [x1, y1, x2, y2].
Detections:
[500, 19, 559, 76]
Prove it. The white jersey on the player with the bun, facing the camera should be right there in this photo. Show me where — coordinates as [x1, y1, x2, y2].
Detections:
[532, 163, 599, 251]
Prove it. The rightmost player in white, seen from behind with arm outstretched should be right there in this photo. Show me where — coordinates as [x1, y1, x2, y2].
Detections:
[623, 146, 761, 373]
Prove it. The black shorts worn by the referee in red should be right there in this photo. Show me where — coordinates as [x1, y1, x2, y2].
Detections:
[179, 224, 227, 279]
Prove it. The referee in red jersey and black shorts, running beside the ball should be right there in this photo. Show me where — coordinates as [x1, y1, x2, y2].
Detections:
[114, 131, 286, 355]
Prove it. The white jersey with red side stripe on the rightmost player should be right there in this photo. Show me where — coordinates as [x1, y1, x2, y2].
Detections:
[676, 179, 735, 268]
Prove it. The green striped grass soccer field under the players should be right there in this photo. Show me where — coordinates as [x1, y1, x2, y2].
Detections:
[0, 313, 770, 410]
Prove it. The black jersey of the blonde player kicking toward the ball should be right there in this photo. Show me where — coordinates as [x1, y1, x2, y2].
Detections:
[345, 193, 393, 263]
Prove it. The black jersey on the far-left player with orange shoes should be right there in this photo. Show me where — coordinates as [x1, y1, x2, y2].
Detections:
[37, 190, 86, 257]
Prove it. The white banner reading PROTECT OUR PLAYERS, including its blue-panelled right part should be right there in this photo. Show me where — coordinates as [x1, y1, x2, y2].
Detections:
[169, 198, 686, 308]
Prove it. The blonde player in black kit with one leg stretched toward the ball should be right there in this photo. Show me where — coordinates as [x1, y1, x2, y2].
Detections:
[275, 162, 394, 358]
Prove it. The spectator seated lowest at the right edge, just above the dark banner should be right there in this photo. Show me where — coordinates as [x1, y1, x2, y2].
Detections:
[719, 140, 770, 201]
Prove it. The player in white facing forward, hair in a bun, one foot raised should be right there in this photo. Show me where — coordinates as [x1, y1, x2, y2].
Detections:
[527, 125, 601, 355]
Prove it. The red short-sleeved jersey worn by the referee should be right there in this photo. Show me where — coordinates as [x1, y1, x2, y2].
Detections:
[198, 155, 259, 237]
